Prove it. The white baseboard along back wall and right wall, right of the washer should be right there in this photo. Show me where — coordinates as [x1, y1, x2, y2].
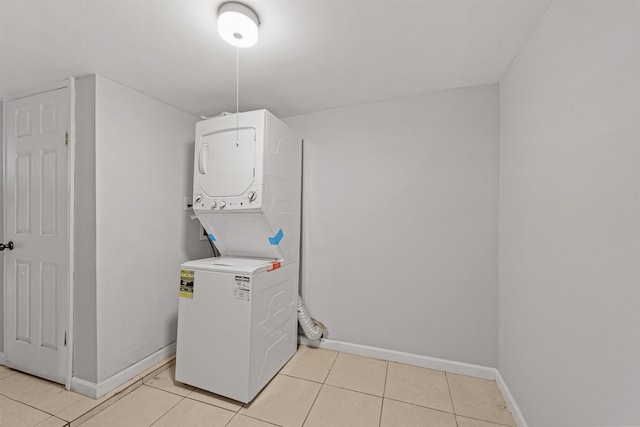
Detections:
[298, 335, 528, 427]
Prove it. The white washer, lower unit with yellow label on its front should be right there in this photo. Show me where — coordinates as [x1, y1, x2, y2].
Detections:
[176, 257, 298, 403]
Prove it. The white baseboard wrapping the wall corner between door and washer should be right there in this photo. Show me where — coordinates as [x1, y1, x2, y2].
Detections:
[71, 342, 176, 399]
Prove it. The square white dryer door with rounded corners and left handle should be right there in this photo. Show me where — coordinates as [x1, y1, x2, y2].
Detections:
[195, 127, 256, 197]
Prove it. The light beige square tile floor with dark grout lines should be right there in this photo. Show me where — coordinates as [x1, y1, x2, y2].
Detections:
[0, 346, 515, 427]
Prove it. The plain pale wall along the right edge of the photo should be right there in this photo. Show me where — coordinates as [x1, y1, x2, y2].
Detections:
[499, 0, 640, 427]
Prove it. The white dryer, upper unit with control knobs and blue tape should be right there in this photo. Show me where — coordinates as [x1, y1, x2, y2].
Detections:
[193, 110, 302, 263]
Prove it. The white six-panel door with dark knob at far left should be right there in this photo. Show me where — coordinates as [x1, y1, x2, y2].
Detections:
[2, 88, 69, 383]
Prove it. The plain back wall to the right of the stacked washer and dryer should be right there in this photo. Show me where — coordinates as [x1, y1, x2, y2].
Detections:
[285, 85, 498, 366]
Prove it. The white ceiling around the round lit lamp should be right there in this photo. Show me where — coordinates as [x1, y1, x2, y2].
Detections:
[0, 0, 552, 117]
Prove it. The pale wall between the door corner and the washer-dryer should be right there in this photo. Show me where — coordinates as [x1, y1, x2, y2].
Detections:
[76, 76, 211, 382]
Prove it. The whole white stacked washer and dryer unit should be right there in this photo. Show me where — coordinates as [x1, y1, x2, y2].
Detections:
[176, 110, 302, 402]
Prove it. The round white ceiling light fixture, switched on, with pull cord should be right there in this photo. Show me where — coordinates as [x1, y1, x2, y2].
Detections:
[218, 2, 260, 47]
